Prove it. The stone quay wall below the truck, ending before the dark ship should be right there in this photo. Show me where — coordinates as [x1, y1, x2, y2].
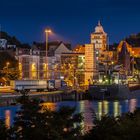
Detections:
[0, 91, 88, 106]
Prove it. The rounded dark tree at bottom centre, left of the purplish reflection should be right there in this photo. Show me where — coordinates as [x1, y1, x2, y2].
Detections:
[46, 106, 83, 140]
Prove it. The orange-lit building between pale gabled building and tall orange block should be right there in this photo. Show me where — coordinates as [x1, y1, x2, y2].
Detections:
[60, 52, 85, 88]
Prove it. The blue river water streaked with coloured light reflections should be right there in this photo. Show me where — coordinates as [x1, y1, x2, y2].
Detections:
[0, 99, 140, 130]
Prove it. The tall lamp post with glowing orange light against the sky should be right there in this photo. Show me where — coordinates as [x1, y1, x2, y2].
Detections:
[45, 29, 52, 79]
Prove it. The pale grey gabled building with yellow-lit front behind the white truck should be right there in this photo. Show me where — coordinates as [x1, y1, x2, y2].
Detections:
[16, 42, 72, 79]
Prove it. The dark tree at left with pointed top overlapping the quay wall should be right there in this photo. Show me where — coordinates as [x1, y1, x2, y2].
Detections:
[12, 90, 41, 140]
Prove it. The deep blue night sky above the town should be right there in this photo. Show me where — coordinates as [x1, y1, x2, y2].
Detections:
[0, 0, 140, 44]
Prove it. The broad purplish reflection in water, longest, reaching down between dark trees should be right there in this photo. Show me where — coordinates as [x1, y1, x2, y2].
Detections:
[79, 101, 94, 133]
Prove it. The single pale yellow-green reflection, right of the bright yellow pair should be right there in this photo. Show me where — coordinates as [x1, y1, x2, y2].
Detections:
[113, 101, 121, 117]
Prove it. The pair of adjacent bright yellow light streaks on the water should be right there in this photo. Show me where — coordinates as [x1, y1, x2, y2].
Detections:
[96, 101, 109, 119]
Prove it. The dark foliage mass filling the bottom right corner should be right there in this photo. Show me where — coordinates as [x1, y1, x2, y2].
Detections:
[84, 109, 140, 140]
